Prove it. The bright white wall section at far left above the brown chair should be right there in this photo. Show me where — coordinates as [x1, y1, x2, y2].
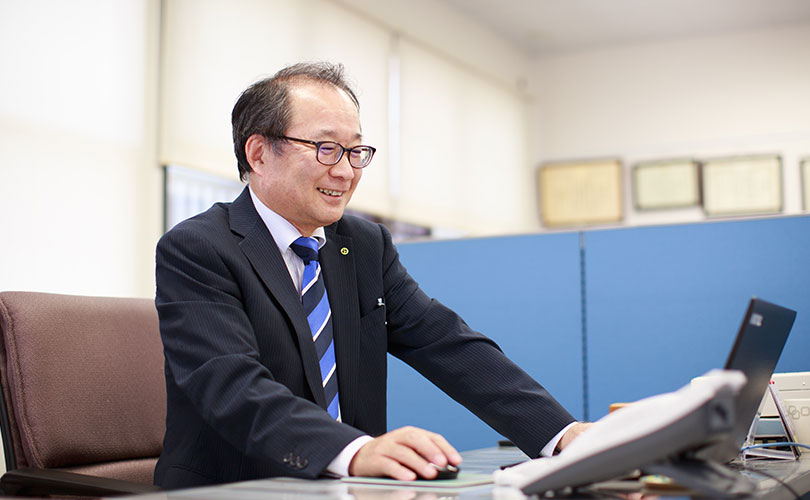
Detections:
[0, 0, 160, 296]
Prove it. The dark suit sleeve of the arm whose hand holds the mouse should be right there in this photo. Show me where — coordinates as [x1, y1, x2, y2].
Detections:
[156, 225, 362, 478]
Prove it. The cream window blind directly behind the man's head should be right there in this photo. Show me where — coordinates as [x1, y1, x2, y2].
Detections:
[160, 0, 390, 215]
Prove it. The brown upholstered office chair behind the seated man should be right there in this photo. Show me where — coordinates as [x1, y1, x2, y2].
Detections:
[0, 292, 166, 497]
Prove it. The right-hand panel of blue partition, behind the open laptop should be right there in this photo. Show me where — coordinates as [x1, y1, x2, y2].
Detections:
[584, 217, 810, 419]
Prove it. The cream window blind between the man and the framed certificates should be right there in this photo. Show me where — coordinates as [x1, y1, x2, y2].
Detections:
[394, 42, 537, 235]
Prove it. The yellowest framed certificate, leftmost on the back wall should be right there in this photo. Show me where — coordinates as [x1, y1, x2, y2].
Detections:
[538, 159, 622, 227]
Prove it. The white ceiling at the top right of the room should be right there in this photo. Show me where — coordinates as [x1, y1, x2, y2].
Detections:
[441, 0, 810, 56]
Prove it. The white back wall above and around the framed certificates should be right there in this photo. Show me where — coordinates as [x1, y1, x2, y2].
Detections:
[531, 25, 810, 225]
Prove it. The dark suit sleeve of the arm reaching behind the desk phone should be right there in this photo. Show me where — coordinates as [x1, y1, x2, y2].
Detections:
[382, 229, 574, 457]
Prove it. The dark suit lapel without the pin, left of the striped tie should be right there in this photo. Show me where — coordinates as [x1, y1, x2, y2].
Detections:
[230, 187, 326, 409]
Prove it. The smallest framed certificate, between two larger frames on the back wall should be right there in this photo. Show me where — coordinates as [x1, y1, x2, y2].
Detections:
[632, 159, 700, 210]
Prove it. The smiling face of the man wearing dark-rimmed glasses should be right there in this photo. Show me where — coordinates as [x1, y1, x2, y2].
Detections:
[250, 82, 362, 236]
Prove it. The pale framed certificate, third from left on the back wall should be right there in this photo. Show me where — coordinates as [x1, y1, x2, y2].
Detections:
[702, 156, 782, 216]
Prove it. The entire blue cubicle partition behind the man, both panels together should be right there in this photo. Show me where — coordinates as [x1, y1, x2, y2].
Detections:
[388, 216, 810, 450]
